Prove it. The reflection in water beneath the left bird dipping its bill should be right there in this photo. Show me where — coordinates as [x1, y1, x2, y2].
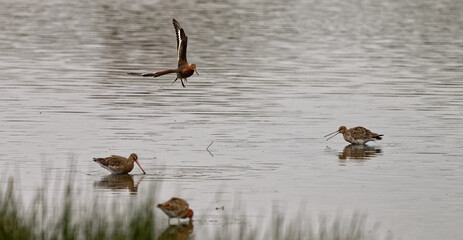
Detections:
[93, 174, 143, 194]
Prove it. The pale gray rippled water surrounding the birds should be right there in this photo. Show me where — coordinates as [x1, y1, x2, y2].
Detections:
[0, 0, 463, 239]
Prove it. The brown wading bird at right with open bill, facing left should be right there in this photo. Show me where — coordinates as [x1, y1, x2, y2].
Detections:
[325, 126, 383, 144]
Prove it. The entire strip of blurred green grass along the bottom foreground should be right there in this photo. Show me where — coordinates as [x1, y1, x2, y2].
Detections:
[0, 180, 392, 240]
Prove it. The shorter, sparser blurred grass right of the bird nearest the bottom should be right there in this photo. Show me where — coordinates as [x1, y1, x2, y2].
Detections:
[213, 206, 393, 240]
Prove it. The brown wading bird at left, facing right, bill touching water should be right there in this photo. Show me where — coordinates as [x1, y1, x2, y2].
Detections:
[93, 153, 146, 174]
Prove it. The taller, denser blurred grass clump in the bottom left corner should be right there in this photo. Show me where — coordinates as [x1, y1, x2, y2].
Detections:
[0, 180, 155, 240]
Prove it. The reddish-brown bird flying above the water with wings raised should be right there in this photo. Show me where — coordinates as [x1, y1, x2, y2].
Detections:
[127, 19, 199, 87]
